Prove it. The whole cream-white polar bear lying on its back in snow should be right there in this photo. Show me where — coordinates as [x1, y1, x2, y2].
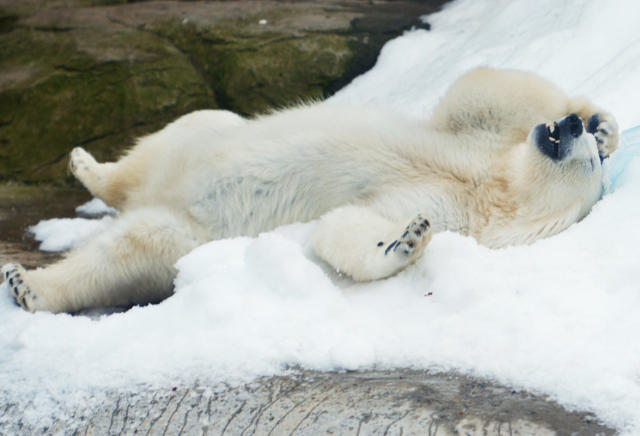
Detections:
[2, 68, 619, 312]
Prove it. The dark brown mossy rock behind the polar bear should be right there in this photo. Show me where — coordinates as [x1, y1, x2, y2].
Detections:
[0, 0, 444, 183]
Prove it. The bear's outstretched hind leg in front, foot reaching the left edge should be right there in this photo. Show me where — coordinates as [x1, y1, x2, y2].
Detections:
[2, 208, 201, 312]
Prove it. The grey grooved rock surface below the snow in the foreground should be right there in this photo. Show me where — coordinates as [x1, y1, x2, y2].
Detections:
[0, 370, 614, 436]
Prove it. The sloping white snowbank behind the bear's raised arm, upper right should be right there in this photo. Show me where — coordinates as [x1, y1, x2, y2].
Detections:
[332, 0, 640, 129]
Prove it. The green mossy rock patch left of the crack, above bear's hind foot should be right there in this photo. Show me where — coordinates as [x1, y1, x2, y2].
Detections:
[0, 24, 215, 181]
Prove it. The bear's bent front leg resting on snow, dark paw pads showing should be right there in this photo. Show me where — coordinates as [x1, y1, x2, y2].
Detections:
[313, 206, 431, 281]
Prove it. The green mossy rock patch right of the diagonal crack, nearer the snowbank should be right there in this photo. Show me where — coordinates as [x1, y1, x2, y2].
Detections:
[158, 17, 354, 115]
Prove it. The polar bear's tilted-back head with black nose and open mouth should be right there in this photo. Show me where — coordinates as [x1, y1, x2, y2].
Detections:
[480, 114, 603, 247]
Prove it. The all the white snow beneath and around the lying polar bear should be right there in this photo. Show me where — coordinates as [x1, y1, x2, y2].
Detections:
[0, 0, 640, 434]
